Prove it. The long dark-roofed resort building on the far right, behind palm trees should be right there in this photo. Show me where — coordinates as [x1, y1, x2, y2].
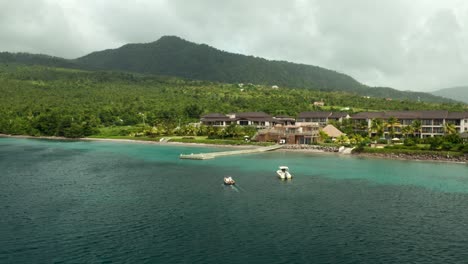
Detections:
[351, 110, 468, 138]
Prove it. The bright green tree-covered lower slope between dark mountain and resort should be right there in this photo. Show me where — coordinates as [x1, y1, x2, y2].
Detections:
[0, 63, 466, 137]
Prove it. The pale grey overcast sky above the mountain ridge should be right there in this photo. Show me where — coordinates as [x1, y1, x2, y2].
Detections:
[0, 0, 468, 91]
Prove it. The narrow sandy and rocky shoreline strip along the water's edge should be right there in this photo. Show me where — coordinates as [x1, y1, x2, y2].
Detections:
[0, 134, 468, 164]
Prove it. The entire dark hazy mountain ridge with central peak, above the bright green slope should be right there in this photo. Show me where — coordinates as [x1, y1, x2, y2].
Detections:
[0, 36, 460, 102]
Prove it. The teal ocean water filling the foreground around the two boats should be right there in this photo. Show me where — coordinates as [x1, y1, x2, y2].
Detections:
[0, 138, 468, 263]
